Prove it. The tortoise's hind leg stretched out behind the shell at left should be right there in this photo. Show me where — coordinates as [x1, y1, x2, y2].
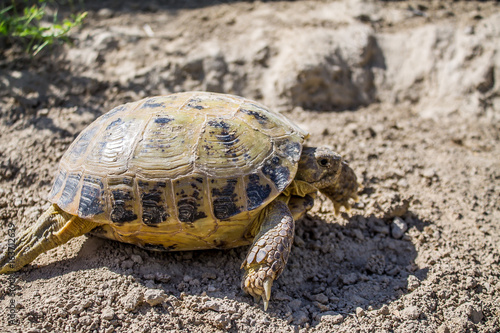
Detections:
[0, 204, 99, 273]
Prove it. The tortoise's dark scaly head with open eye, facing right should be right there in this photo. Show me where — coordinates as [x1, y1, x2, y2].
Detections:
[295, 147, 359, 213]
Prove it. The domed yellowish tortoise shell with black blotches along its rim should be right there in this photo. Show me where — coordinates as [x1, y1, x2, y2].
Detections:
[49, 92, 307, 250]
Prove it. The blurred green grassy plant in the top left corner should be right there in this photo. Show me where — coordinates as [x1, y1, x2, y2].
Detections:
[0, 0, 87, 55]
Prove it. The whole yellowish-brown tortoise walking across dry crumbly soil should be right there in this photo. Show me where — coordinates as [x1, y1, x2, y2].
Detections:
[0, 92, 358, 310]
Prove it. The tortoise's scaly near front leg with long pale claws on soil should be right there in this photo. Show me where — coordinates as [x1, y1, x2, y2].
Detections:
[241, 200, 295, 310]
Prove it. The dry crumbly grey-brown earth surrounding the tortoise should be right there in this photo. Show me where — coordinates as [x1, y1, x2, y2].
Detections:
[0, 0, 500, 333]
